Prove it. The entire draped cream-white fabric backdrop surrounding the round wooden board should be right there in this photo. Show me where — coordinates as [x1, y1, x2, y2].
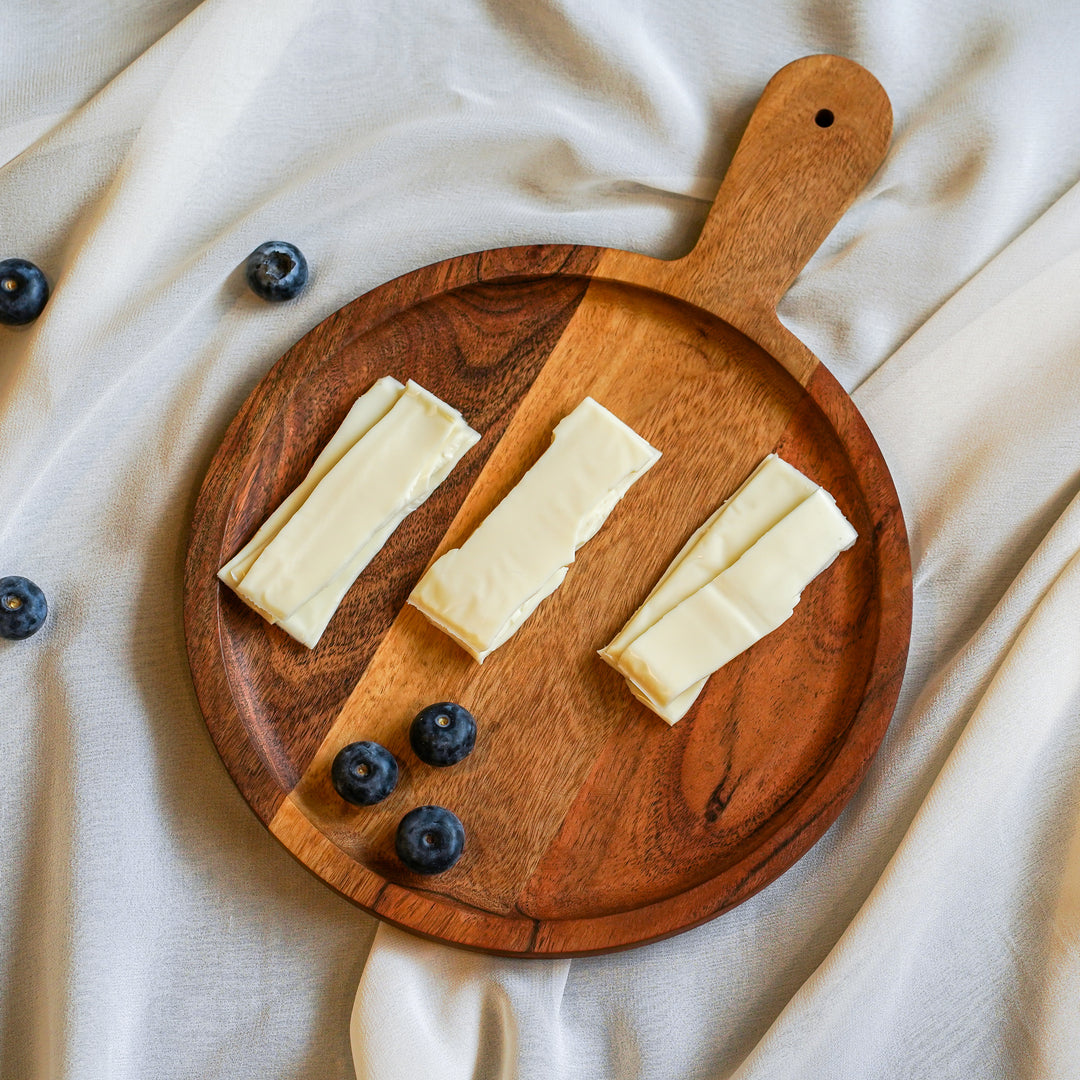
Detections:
[0, 0, 1080, 1080]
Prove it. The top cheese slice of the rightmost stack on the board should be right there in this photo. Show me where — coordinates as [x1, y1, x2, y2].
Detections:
[619, 488, 856, 719]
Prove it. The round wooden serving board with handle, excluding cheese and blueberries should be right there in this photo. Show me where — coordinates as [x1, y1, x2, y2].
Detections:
[185, 56, 910, 956]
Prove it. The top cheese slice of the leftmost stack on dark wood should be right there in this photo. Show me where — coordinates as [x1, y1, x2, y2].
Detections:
[237, 381, 480, 632]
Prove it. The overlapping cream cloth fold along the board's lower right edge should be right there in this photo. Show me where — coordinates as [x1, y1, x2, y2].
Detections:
[352, 187, 1080, 1080]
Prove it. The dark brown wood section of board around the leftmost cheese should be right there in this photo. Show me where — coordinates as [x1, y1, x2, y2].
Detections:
[185, 247, 609, 822]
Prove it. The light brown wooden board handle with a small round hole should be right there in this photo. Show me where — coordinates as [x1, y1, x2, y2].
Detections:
[604, 55, 892, 377]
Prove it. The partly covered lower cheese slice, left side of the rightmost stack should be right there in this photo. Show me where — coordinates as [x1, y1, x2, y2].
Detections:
[600, 454, 818, 665]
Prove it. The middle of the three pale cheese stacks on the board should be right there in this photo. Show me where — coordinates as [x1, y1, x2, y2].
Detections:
[409, 397, 660, 662]
